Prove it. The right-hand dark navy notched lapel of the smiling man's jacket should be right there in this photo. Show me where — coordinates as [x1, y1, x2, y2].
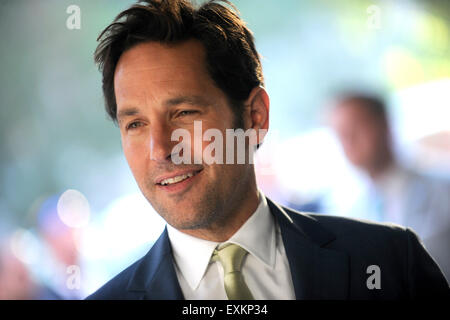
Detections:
[267, 199, 349, 300]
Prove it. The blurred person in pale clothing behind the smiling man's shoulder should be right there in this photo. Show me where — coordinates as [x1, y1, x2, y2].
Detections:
[327, 93, 450, 278]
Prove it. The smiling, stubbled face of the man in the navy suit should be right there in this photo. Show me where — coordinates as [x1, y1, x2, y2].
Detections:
[114, 40, 248, 229]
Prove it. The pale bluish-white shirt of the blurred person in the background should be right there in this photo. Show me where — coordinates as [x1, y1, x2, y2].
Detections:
[323, 165, 450, 279]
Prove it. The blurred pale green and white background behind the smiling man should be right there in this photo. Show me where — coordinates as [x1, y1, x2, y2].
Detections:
[0, 0, 450, 299]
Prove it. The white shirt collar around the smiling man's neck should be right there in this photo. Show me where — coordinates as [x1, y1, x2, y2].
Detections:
[167, 191, 276, 290]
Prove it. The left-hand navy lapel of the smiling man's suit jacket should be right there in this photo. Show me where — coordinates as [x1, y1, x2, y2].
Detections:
[128, 228, 184, 300]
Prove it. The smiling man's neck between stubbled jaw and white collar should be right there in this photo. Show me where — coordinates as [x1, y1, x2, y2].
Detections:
[180, 171, 259, 242]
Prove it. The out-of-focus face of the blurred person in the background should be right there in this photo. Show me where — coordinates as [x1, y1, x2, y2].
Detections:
[331, 101, 387, 169]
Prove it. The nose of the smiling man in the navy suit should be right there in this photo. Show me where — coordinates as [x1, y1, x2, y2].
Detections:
[149, 123, 173, 162]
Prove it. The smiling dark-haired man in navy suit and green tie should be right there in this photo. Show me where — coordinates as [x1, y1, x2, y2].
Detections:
[89, 0, 448, 299]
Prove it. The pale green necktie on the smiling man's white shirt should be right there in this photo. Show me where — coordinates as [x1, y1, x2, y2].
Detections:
[211, 244, 253, 300]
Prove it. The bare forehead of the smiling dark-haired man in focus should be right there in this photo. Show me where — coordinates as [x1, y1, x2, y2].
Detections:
[114, 40, 226, 112]
